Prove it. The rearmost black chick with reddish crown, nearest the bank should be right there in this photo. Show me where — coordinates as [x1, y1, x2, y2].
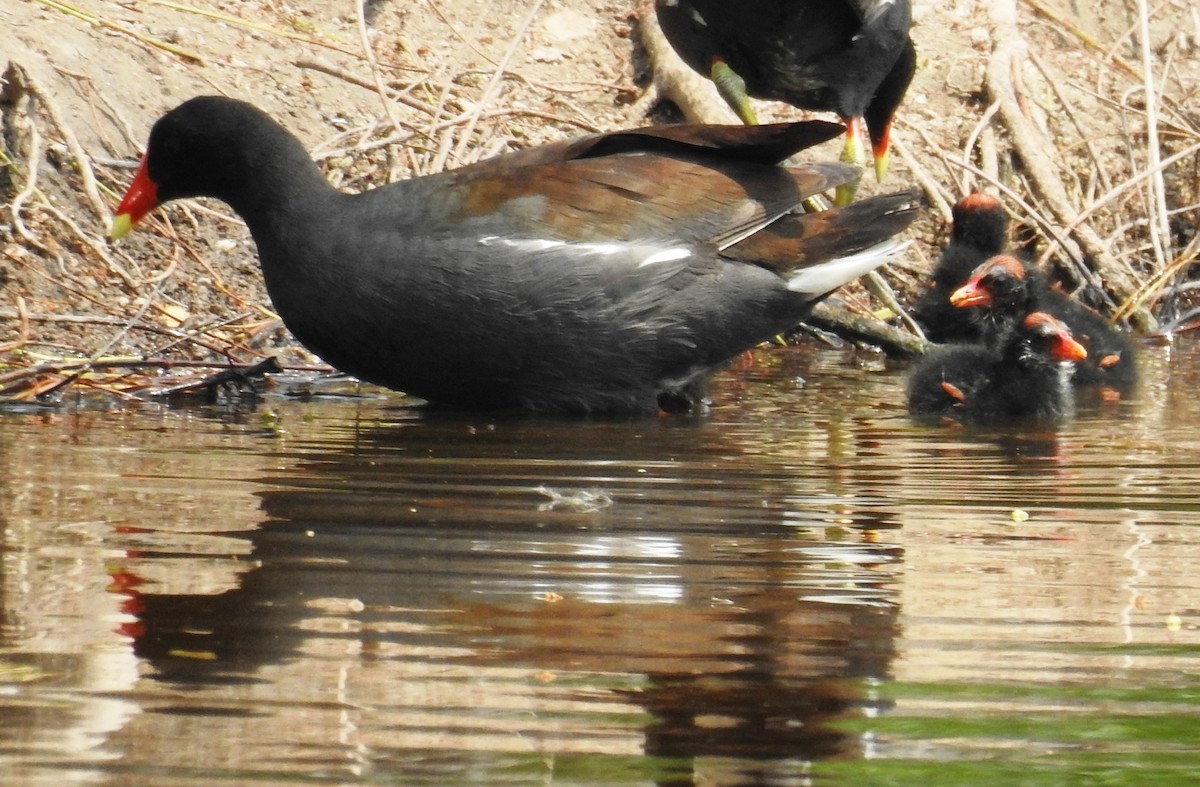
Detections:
[912, 192, 1008, 342]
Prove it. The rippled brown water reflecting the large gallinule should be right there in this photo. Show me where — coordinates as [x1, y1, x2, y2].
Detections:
[0, 343, 1200, 785]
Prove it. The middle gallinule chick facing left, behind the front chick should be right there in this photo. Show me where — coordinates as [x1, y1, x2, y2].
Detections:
[949, 254, 1138, 392]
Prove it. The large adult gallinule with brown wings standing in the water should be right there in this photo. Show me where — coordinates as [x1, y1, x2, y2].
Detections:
[112, 97, 916, 413]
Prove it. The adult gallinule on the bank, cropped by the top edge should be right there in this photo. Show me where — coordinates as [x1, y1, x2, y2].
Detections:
[655, 0, 917, 180]
